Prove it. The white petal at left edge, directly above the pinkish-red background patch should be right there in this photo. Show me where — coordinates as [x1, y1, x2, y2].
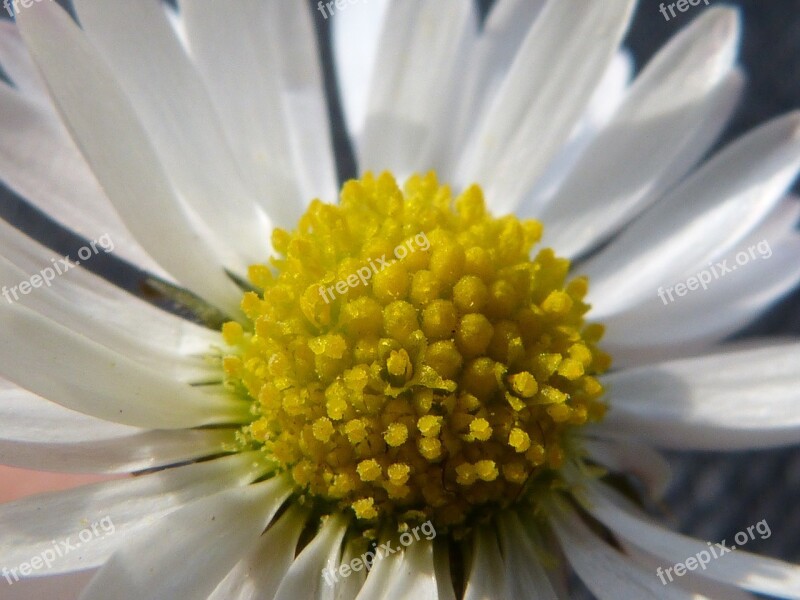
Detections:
[0, 382, 234, 473]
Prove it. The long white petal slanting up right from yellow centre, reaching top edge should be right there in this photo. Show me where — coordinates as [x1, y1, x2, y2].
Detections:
[458, 0, 635, 212]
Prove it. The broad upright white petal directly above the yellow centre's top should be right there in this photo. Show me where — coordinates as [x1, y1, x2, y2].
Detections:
[357, 0, 476, 179]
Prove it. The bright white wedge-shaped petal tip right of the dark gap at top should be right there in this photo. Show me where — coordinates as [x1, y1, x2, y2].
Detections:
[332, 0, 389, 139]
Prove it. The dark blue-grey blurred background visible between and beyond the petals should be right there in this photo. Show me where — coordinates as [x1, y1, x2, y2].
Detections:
[0, 0, 800, 598]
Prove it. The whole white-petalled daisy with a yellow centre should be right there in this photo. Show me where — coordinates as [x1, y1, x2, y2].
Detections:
[0, 0, 800, 600]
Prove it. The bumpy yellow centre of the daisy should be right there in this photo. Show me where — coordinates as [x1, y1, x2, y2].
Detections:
[223, 174, 609, 530]
